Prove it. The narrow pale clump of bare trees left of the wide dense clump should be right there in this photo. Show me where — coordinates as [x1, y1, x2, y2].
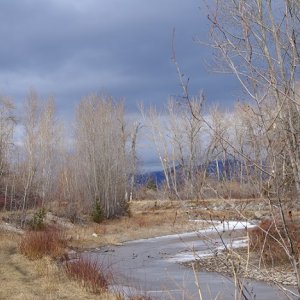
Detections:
[19, 90, 62, 211]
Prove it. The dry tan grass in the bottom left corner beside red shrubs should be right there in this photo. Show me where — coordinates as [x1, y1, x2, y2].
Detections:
[0, 231, 116, 300]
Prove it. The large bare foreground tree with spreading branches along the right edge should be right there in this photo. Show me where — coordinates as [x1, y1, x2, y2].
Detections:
[205, 0, 300, 293]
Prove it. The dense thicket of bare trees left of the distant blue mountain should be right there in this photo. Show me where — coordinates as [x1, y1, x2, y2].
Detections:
[0, 91, 138, 222]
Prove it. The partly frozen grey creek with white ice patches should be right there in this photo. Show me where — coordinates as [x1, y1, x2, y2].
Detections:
[83, 222, 296, 300]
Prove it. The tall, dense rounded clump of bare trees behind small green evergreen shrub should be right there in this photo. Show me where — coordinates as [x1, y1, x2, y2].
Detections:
[75, 95, 130, 218]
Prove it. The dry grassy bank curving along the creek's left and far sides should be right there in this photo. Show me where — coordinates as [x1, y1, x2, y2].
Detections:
[0, 200, 268, 299]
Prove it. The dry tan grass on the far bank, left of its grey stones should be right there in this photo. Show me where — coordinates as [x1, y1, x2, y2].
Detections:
[68, 201, 196, 248]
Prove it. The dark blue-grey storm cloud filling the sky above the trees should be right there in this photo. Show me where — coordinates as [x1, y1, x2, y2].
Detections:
[0, 0, 239, 113]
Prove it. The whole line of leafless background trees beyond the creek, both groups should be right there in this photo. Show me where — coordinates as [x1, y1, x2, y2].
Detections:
[0, 91, 267, 218]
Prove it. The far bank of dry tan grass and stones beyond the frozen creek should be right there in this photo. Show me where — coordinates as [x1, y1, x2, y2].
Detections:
[68, 199, 262, 248]
